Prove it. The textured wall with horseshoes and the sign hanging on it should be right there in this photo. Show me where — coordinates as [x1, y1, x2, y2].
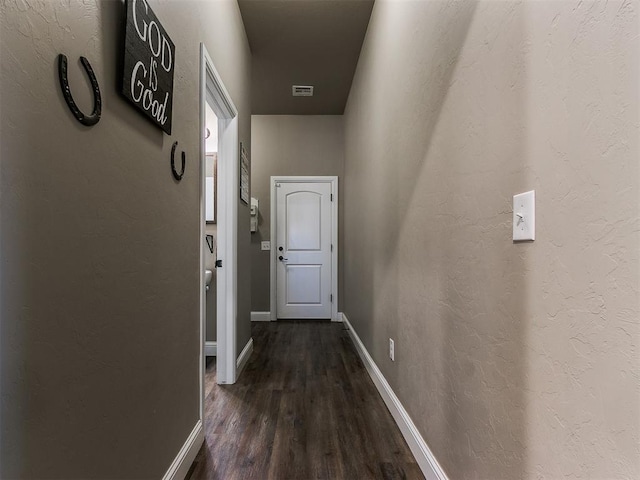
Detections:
[0, 0, 251, 479]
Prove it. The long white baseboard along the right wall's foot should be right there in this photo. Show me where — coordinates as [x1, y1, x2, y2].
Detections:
[342, 313, 448, 480]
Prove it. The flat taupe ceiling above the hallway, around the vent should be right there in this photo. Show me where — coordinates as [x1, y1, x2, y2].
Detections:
[238, 0, 374, 115]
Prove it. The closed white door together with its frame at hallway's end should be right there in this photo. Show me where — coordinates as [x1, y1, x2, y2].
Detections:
[270, 176, 338, 322]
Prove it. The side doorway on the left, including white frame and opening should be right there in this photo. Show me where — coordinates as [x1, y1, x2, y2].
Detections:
[200, 44, 238, 421]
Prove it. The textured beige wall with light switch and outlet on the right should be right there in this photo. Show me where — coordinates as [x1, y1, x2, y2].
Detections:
[343, 0, 640, 480]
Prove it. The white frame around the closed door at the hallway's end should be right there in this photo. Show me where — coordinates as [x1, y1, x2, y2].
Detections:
[270, 176, 338, 322]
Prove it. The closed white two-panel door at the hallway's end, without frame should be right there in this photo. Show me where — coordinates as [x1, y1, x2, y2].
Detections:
[274, 182, 332, 319]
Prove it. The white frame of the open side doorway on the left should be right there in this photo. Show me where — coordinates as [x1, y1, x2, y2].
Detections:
[200, 43, 239, 408]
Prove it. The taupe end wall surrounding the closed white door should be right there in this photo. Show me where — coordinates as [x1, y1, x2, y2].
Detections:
[251, 115, 344, 312]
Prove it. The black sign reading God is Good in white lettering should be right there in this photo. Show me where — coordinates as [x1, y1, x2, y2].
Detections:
[122, 0, 176, 135]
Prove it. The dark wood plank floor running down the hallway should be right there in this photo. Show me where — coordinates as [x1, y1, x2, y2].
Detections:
[190, 320, 424, 480]
